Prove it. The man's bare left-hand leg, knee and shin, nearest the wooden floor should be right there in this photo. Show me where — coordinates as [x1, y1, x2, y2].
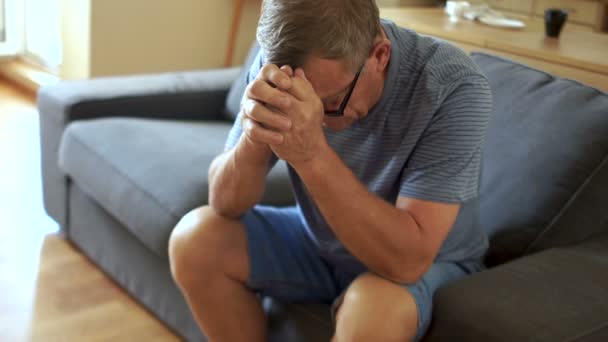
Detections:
[169, 206, 266, 342]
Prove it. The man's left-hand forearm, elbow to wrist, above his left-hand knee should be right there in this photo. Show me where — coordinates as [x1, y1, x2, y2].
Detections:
[209, 136, 272, 218]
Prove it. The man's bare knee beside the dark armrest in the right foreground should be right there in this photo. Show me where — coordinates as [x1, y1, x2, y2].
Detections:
[333, 273, 418, 342]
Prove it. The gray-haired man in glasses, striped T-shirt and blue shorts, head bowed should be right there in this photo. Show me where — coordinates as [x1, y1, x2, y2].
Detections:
[169, 0, 491, 341]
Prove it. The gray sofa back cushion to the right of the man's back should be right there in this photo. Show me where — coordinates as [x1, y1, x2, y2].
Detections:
[472, 53, 608, 264]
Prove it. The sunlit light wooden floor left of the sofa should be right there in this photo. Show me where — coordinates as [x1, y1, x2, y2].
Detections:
[0, 79, 179, 342]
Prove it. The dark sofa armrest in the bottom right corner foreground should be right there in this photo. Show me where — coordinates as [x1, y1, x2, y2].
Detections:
[426, 233, 608, 341]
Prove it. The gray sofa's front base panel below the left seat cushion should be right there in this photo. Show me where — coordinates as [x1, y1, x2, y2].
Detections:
[68, 186, 204, 341]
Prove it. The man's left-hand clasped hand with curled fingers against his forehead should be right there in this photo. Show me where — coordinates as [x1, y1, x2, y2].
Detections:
[241, 64, 293, 149]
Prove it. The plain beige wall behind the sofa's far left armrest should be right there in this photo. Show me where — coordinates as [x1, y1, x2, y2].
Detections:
[62, 0, 259, 79]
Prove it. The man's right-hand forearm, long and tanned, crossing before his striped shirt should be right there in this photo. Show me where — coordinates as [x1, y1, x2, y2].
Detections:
[294, 147, 432, 282]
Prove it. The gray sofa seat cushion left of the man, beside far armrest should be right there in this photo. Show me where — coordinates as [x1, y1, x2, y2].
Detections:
[59, 118, 292, 259]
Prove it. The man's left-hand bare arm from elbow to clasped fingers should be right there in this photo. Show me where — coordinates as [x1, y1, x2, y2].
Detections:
[209, 65, 292, 218]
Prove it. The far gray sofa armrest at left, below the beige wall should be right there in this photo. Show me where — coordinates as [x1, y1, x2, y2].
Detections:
[38, 68, 240, 232]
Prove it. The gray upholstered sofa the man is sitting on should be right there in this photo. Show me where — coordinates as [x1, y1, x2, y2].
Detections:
[38, 43, 608, 342]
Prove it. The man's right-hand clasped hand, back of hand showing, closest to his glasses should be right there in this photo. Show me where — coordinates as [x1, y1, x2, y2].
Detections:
[270, 69, 326, 167]
